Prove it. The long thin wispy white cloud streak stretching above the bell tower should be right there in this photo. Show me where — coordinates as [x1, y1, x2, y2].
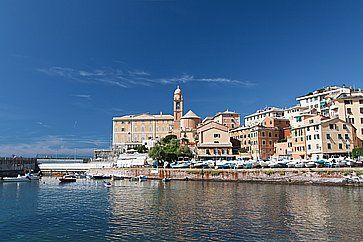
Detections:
[38, 66, 257, 88]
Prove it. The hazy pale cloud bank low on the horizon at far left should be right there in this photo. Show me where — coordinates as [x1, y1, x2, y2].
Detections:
[0, 136, 108, 157]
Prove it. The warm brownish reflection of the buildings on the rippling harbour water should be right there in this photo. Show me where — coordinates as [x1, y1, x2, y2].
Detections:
[107, 181, 363, 240]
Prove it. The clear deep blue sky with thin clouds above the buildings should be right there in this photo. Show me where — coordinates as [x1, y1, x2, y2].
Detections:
[0, 0, 363, 156]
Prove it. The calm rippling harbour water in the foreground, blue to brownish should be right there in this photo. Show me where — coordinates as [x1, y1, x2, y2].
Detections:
[0, 178, 363, 241]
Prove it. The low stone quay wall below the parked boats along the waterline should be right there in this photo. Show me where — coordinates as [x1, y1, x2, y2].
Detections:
[84, 168, 363, 186]
